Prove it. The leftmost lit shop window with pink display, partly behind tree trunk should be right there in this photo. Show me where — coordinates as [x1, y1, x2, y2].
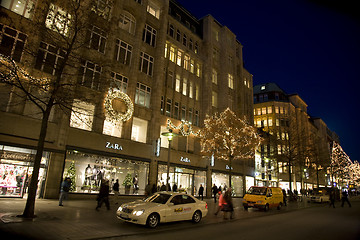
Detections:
[0, 145, 50, 198]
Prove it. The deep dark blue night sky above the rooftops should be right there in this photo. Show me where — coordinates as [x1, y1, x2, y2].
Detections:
[178, 0, 360, 161]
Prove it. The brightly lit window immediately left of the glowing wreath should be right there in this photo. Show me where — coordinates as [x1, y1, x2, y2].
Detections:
[70, 99, 95, 131]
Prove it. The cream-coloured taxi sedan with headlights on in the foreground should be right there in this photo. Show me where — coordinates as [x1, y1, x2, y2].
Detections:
[116, 191, 208, 228]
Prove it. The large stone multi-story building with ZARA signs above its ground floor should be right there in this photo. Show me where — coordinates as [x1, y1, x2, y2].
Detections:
[0, 0, 254, 198]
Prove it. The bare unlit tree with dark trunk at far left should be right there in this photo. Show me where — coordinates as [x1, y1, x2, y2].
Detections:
[0, 0, 111, 218]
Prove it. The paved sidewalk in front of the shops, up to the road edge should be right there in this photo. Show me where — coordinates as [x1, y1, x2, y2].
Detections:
[0, 197, 359, 240]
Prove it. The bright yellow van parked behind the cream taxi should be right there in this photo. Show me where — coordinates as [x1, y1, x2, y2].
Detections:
[243, 187, 284, 211]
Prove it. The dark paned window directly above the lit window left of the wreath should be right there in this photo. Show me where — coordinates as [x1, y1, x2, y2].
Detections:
[80, 61, 101, 90]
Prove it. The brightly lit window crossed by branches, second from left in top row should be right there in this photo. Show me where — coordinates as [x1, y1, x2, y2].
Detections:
[45, 3, 71, 36]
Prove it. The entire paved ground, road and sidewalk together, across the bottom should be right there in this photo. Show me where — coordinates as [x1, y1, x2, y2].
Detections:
[0, 197, 360, 240]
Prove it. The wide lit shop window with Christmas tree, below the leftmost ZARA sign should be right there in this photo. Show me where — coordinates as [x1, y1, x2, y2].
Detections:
[63, 150, 149, 195]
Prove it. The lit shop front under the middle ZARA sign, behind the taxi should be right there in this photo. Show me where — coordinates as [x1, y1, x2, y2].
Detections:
[157, 164, 206, 196]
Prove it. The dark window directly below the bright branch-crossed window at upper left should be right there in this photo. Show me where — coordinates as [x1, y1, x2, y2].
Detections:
[35, 42, 65, 75]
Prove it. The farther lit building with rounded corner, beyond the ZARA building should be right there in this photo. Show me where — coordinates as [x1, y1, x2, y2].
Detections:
[254, 83, 338, 191]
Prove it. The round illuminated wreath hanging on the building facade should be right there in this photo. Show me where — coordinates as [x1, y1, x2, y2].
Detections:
[104, 89, 134, 124]
